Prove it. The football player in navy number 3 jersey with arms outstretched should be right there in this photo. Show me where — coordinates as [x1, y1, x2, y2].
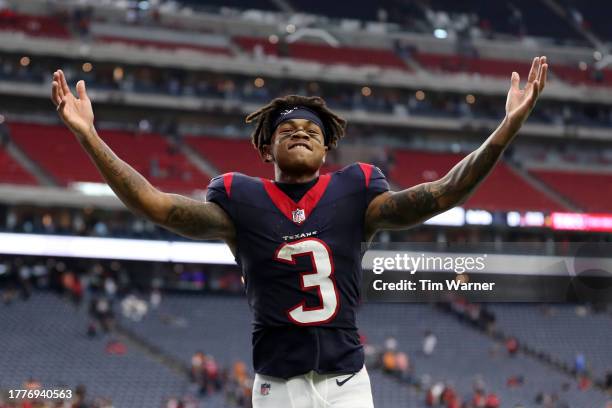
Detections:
[52, 57, 548, 408]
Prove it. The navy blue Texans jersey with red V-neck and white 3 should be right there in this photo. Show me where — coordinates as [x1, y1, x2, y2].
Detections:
[206, 163, 389, 378]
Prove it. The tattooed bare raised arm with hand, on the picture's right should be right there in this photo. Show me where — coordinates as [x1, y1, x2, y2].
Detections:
[366, 57, 548, 239]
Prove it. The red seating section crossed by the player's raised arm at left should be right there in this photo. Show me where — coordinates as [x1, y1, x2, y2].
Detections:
[9, 123, 210, 191]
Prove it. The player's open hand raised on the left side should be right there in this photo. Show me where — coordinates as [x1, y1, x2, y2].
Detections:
[51, 70, 94, 136]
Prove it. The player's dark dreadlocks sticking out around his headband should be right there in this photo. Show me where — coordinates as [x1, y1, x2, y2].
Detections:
[246, 95, 346, 156]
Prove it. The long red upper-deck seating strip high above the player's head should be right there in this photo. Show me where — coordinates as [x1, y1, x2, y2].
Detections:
[233, 37, 409, 70]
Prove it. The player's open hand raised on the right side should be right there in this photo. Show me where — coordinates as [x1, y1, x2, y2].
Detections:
[506, 57, 548, 127]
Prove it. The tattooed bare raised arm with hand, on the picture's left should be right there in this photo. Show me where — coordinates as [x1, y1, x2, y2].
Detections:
[51, 71, 235, 247]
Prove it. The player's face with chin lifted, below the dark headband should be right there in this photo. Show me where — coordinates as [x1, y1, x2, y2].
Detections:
[265, 119, 327, 175]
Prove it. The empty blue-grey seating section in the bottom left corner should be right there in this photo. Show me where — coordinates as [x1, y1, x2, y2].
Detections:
[0, 293, 189, 407]
